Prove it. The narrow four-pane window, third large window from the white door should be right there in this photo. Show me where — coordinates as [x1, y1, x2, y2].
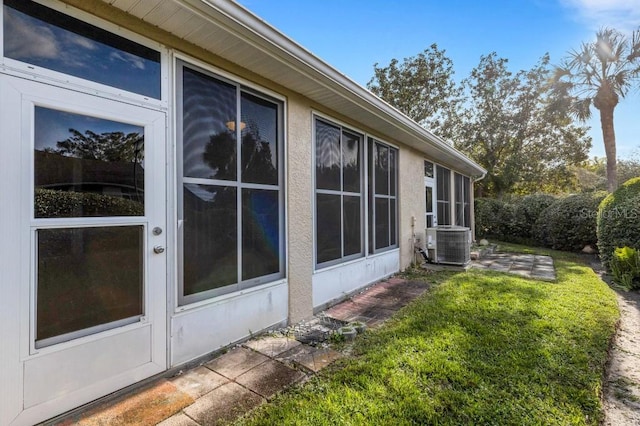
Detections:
[369, 138, 398, 253]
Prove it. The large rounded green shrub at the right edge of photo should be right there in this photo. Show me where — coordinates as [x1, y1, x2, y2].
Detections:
[598, 177, 640, 268]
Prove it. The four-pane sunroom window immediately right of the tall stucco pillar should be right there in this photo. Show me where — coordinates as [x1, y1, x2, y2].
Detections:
[315, 119, 364, 266]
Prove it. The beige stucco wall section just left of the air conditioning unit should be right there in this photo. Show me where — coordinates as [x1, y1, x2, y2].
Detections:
[398, 147, 426, 269]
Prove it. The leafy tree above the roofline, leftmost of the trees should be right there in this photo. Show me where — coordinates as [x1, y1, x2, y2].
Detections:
[367, 43, 461, 138]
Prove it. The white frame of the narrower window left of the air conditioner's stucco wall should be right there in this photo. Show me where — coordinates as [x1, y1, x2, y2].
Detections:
[367, 136, 400, 254]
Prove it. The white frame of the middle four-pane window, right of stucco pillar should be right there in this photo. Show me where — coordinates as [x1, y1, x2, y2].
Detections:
[312, 112, 367, 271]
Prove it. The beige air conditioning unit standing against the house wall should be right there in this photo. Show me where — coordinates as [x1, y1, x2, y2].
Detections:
[425, 226, 471, 266]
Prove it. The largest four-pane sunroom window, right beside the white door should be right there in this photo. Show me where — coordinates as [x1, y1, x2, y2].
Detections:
[178, 61, 284, 304]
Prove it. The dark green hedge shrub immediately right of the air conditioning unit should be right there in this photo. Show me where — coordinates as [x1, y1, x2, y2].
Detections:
[475, 198, 514, 241]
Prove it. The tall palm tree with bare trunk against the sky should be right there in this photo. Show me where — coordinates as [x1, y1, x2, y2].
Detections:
[554, 28, 640, 192]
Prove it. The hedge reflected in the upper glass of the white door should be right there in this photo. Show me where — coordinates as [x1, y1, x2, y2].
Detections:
[35, 188, 144, 217]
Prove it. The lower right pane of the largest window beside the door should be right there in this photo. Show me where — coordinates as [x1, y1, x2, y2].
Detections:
[242, 189, 280, 280]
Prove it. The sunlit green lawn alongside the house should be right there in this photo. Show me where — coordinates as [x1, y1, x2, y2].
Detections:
[239, 245, 619, 425]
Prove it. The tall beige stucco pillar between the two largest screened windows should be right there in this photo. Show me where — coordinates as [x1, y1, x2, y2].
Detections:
[286, 96, 315, 323]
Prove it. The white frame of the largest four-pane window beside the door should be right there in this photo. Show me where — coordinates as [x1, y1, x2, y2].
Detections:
[173, 60, 287, 310]
